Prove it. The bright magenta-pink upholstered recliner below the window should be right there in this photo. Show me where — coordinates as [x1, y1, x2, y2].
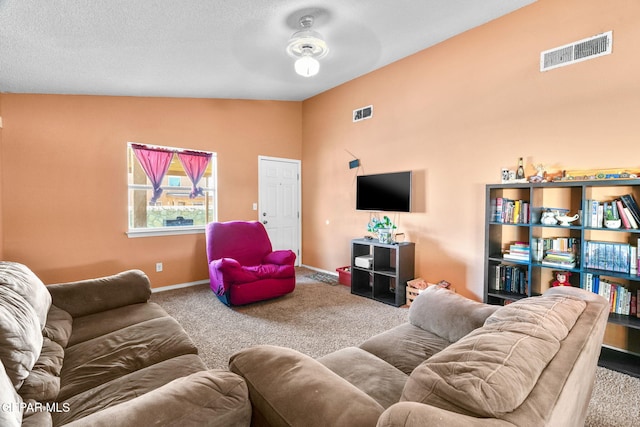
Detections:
[206, 221, 296, 306]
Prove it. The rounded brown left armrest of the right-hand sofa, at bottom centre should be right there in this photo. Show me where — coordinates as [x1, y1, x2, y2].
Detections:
[229, 345, 384, 427]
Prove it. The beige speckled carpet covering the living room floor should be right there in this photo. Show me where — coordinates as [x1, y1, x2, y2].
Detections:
[151, 268, 640, 427]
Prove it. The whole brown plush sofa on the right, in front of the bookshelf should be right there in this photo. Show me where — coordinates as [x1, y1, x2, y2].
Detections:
[230, 287, 609, 427]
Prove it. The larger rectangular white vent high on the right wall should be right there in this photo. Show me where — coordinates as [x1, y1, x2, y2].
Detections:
[540, 31, 613, 71]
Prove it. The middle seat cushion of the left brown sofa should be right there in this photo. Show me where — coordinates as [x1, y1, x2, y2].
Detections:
[58, 316, 197, 400]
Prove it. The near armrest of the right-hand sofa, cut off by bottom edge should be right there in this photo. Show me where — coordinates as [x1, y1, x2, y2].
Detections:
[376, 402, 515, 427]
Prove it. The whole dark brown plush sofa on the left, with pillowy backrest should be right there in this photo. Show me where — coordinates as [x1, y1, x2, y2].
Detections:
[0, 262, 251, 427]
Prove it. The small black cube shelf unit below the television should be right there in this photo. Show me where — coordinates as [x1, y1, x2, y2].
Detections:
[351, 239, 415, 307]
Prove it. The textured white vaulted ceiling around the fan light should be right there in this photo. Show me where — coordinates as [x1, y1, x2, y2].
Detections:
[0, 0, 535, 100]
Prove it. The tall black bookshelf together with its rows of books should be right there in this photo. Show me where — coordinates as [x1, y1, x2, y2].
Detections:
[484, 179, 640, 372]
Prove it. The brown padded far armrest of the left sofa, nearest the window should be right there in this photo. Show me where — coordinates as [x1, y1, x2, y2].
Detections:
[47, 270, 151, 317]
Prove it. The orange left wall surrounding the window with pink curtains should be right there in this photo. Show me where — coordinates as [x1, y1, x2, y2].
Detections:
[0, 94, 302, 287]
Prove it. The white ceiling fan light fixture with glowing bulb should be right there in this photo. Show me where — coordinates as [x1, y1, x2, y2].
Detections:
[287, 15, 329, 77]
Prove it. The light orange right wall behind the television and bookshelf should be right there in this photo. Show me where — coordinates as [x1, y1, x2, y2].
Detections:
[302, 0, 640, 299]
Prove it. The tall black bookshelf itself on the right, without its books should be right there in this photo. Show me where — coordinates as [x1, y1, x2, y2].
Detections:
[484, 179, 640, 377]
